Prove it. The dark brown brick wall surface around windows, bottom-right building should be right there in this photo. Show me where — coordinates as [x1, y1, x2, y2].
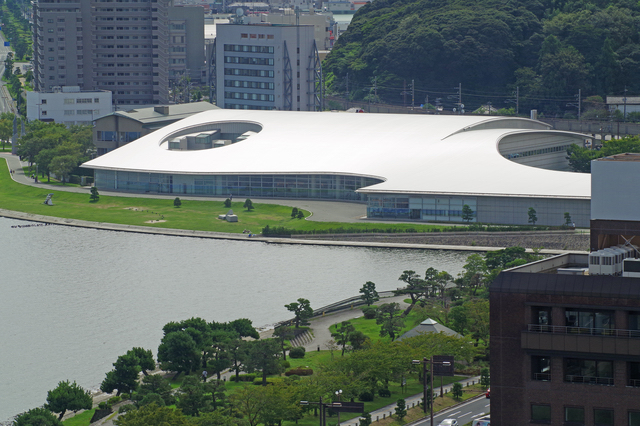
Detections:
[490, 272, 640, 426]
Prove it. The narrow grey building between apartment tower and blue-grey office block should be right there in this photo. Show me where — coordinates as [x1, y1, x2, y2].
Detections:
[169, 6, 206, 83]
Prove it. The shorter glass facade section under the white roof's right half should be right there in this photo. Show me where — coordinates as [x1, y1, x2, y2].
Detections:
[367, 195, 477, 222]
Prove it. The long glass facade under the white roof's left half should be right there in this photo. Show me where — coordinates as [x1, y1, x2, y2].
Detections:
[95, 170, 381, 201]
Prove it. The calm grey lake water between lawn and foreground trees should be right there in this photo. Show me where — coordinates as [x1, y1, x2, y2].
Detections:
[0, 218, 470, 421]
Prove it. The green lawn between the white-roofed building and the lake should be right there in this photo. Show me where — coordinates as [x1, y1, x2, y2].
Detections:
[0, 161, 452, 233]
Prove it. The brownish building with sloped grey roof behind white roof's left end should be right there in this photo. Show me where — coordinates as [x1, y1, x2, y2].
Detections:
[93, 102, 219, 155]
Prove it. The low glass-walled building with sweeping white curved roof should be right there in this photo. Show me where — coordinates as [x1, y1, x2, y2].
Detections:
[85, 110, 591, 226]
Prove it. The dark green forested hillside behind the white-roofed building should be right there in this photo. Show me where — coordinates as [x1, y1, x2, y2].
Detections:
[323, 0, 640, 114]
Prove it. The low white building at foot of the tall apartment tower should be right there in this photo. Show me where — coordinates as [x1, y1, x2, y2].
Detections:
[27, 86, 113, 126]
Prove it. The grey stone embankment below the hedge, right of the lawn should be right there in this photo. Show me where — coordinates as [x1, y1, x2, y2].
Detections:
[294, 231, 589, 251]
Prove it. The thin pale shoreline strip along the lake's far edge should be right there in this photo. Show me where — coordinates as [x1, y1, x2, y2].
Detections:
[0, 209, 581, 255]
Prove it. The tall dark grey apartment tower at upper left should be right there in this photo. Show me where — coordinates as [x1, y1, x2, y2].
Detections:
[33, 0, 170, 108]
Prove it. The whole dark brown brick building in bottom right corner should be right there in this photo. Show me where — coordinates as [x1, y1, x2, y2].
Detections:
[490, 254, 640, 426]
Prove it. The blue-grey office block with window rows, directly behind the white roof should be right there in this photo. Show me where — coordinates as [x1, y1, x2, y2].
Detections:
[212, 24, 322, 111]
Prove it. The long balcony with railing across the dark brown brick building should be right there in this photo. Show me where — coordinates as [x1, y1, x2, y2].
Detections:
[520, 324, 640, 356]
